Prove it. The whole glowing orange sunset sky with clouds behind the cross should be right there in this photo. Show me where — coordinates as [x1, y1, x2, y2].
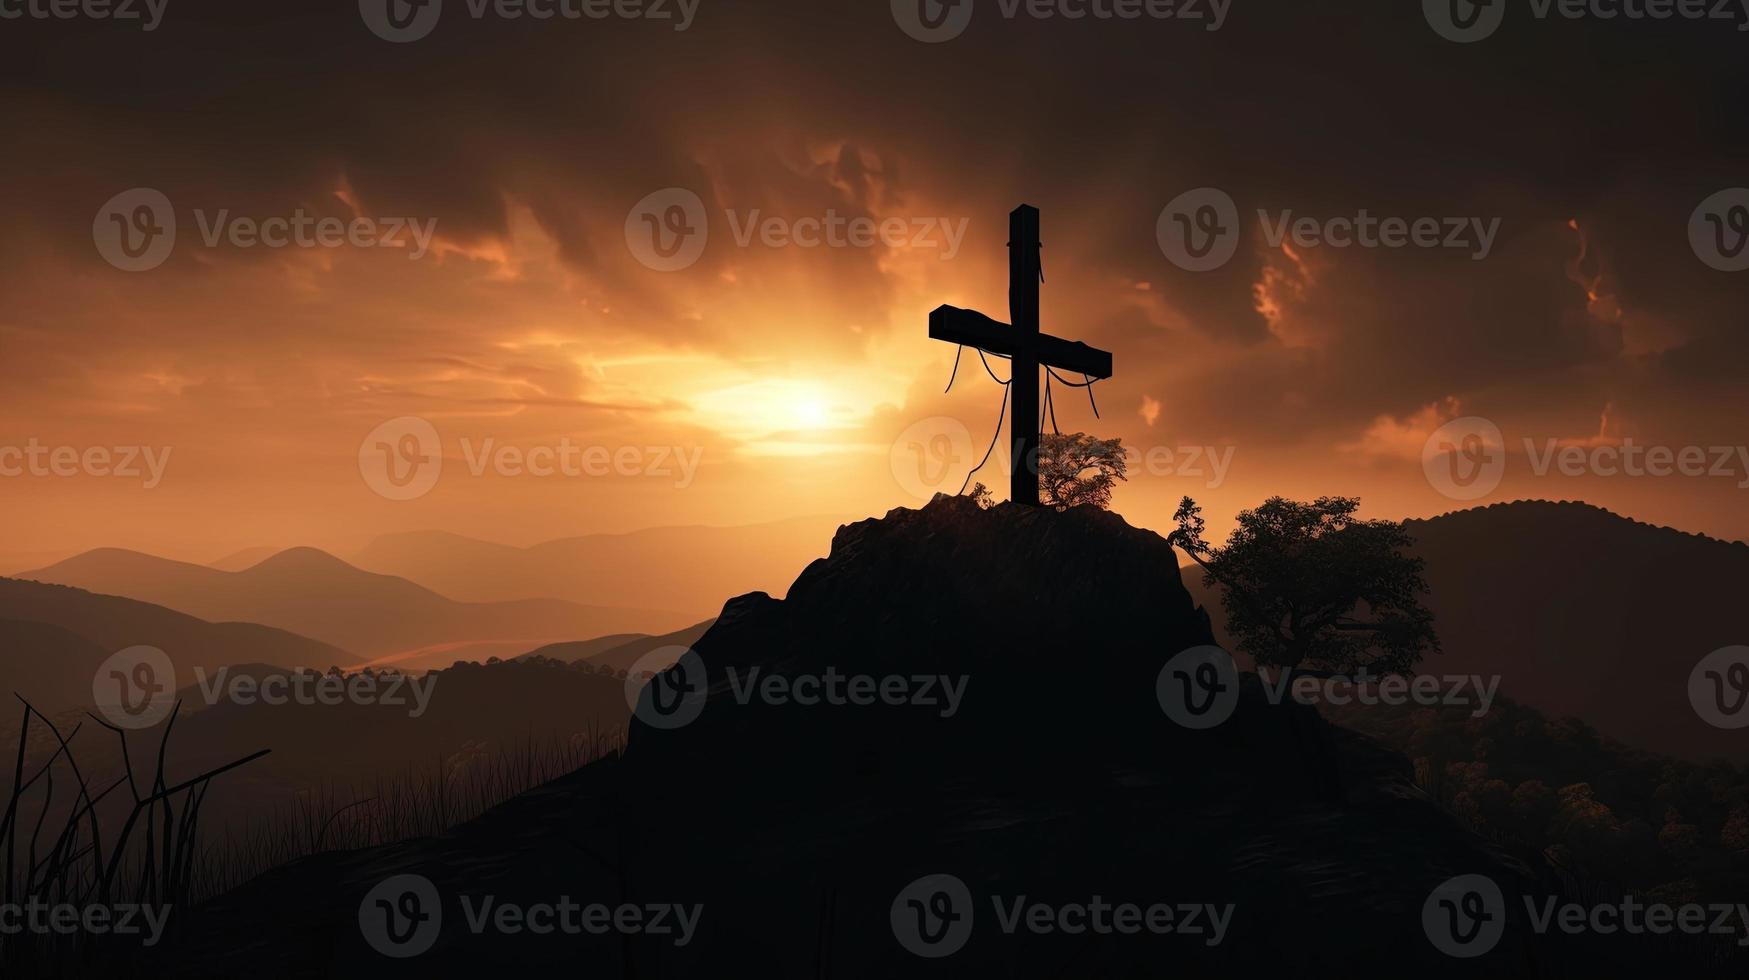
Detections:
[0, 0, 1749, 572]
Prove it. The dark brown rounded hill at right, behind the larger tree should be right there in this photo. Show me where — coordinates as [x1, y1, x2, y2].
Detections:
[1186, 501, 1749, 761]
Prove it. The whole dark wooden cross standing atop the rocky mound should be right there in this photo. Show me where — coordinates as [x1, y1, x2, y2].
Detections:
[929, 205, 1111, 508]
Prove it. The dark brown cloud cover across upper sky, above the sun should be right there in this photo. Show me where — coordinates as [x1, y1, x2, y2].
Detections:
[0, 0, 1749, 546]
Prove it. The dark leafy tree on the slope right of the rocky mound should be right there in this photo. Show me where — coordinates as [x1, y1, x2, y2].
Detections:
[1168, 497, 1439, 674]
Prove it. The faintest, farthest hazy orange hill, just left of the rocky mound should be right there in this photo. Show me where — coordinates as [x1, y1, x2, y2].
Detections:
[352, 516, 840, 612]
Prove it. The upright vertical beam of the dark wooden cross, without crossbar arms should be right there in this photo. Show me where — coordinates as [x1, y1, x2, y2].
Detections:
[1007, 205, 1039, 508]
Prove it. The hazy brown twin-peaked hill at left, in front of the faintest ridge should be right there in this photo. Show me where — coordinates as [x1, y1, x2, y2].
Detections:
[21, 548, 693, 667]
